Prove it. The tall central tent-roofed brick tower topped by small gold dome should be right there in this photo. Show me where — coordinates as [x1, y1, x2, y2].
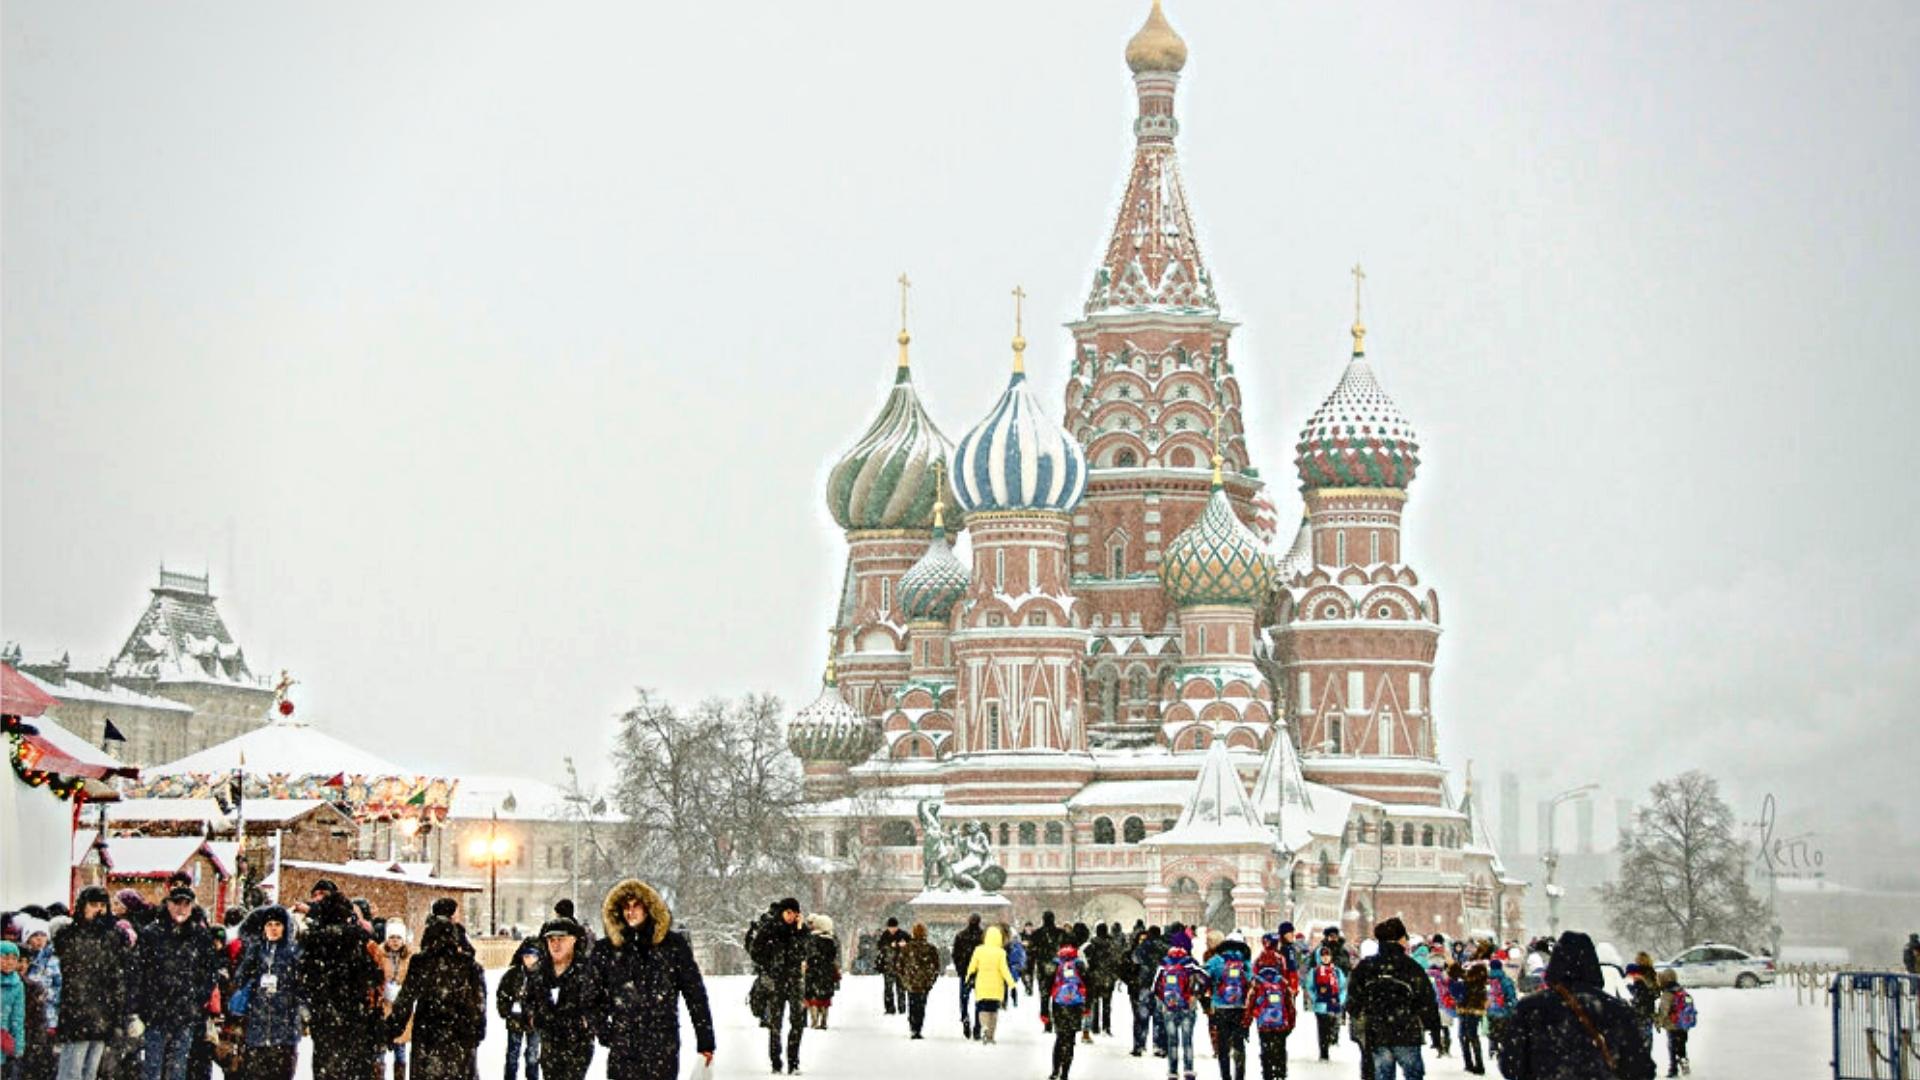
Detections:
[1066, 0, 1261, 744]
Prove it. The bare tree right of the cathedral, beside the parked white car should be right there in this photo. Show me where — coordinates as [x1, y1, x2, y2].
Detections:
[1599, 771, 1772, 953]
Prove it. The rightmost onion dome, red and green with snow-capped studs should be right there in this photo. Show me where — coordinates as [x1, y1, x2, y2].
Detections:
[1294, 321, 1421, 490]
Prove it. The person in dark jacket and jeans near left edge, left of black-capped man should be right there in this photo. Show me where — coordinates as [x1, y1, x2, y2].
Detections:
[54, 886, 132, 1080]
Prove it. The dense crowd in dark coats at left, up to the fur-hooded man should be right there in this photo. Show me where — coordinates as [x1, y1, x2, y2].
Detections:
[0, 876, 714, 1080]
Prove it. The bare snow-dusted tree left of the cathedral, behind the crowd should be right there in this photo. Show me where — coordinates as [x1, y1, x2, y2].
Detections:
[612, 690, 806, 955]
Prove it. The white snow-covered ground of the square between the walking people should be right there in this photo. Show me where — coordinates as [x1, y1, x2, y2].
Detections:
[298, 972, 1832, 1080]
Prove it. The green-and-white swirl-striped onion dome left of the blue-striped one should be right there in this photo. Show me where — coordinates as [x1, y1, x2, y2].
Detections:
[828, 299, 967, 530]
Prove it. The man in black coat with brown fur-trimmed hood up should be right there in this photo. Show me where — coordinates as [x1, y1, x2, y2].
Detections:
[588, 878, 714, 1080]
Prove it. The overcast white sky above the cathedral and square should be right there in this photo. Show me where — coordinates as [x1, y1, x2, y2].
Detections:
[0, 0, 1920, 853]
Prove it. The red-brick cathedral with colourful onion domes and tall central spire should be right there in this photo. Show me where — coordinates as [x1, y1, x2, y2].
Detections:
[789, 0, 1524, 940]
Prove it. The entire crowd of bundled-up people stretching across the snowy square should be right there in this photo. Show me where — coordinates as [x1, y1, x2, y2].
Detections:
[22, 878, 1889, 1080]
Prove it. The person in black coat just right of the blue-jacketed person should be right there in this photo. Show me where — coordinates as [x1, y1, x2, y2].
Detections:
[298, 892, 384, 1080]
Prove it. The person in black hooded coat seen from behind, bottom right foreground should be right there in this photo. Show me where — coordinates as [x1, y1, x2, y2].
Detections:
[1489, 930, 1657, 1080]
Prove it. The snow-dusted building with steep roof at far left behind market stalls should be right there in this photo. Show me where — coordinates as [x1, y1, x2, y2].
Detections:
[0, 567, 273, 765]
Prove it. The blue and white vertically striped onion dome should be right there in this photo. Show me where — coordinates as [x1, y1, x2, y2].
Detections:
[954, 371, 1087, 513]
